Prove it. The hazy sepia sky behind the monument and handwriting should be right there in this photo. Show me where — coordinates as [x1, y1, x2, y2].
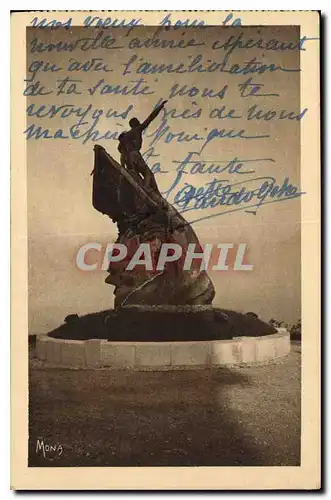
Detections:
[27, 26, 301, 333]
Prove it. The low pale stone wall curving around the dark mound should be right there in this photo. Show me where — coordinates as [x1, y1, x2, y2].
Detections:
[36, 328, 291, 370]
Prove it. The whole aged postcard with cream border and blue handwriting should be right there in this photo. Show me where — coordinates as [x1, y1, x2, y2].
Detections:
[11, 11, 320, 490]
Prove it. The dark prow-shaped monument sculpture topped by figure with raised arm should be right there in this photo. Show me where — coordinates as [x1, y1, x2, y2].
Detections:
[92, 101, 215, 308]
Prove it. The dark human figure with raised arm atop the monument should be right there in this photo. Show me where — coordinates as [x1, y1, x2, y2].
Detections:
[118, 101, 167, 191]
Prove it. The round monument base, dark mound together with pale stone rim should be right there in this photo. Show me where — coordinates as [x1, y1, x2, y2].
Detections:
[31, 306, 290, 370]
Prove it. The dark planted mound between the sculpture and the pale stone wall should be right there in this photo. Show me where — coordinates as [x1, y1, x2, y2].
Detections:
[49, 305, 276, 342]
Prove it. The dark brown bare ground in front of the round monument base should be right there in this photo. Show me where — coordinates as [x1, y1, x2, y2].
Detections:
[29, 343, 301, 467]
